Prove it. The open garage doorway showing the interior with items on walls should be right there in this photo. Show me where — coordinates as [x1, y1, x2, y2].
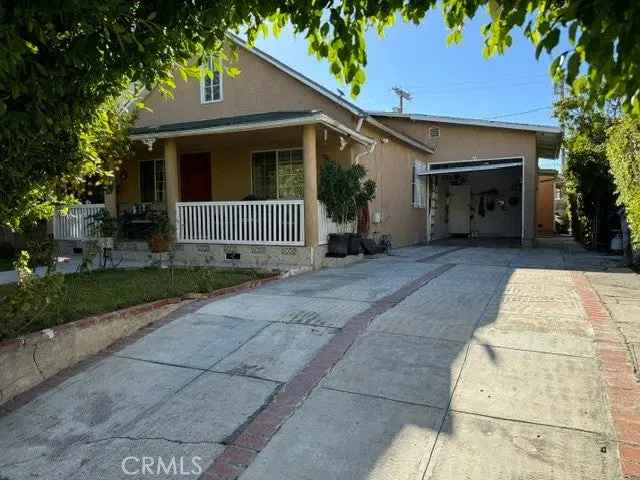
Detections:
[424, 158, 525, 241]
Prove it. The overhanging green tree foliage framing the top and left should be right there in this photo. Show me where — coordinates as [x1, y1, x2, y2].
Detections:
[0, 0, 640, 228]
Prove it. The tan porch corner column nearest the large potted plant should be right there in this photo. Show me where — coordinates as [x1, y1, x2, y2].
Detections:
[302, 125, 318, 247]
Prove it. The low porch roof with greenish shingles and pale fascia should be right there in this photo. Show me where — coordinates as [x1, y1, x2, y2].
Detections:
[129, 110, 375, 145]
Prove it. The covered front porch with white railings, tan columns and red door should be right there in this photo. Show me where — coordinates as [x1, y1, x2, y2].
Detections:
[54, 113, 373, 267]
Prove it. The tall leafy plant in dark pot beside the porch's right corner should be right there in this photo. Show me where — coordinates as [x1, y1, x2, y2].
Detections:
[318, 160, 376, 257]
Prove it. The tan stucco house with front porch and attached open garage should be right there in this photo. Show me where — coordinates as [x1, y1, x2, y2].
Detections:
[52, 37, 561, 266]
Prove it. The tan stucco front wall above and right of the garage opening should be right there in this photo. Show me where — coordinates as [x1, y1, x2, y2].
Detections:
[378, 117, 538, 244]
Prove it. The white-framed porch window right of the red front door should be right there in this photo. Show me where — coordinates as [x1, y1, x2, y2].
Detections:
[251, 148, 304, 200]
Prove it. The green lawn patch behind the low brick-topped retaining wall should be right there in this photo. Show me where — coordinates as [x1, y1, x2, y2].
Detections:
[0, 267, 271, 340]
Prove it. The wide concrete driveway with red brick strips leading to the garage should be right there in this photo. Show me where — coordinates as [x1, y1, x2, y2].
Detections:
[0, 246, 640, 480]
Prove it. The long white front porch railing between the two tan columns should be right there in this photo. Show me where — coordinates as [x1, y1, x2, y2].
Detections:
[176, 200, 304, 245]
